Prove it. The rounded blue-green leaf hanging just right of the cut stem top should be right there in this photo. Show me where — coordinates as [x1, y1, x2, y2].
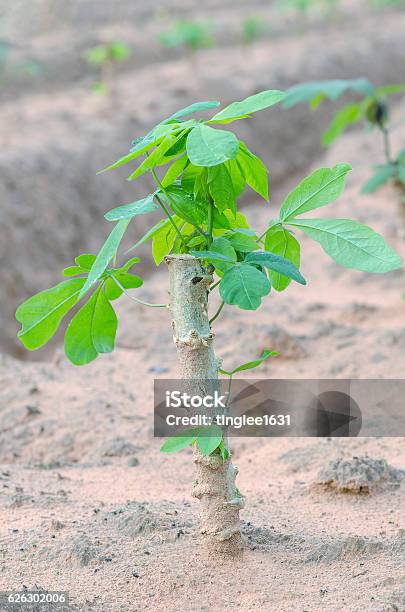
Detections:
[219, 263, 271, 310]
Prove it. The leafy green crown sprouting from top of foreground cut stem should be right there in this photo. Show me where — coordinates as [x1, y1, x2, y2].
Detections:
[16, 85, 402, 364]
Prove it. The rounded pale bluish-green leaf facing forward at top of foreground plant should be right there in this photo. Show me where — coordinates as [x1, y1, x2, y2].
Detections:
[186, 123, 239, 167]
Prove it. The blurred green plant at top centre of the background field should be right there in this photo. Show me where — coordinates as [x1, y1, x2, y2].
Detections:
[159, 19, 214, 54]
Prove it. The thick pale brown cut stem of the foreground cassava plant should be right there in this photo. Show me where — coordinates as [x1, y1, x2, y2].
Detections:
[166, 255, 244, 556]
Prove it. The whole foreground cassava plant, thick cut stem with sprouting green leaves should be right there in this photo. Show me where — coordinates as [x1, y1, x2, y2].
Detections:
[16, 91, 402, 555]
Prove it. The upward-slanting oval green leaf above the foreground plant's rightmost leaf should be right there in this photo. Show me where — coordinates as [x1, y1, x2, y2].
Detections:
[280, 164, 351, 222]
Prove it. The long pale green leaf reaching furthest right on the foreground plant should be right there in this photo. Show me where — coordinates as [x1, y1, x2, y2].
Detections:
[289, 219, 402, 274]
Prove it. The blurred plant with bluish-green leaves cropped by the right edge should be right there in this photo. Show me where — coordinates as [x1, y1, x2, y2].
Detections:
[283, 78, 405, 193]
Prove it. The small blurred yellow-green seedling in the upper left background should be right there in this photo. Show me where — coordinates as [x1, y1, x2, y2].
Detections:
[85, 41, 132, 95]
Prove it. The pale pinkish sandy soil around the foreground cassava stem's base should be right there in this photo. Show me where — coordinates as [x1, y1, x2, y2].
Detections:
[0, 110, 405, 612]
